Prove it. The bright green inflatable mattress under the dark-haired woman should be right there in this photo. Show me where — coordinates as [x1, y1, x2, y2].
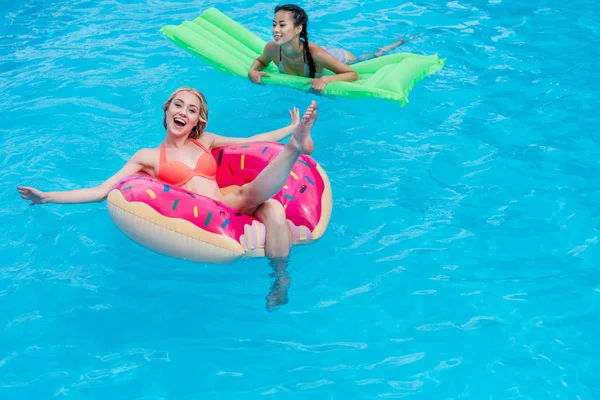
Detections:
[160, 8, 446, 106]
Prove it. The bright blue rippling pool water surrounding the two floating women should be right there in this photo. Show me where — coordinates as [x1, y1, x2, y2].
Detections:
[0, 0, 600, 399]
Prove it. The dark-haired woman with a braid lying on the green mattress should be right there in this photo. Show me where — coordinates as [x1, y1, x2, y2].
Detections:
[248, 4, 412, 93]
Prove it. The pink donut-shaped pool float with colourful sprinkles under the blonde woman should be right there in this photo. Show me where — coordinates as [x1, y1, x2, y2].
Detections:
[107, 142, 332, 263]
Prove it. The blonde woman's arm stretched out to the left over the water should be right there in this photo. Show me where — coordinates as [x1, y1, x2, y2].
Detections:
[17, 149, 152, 206]
